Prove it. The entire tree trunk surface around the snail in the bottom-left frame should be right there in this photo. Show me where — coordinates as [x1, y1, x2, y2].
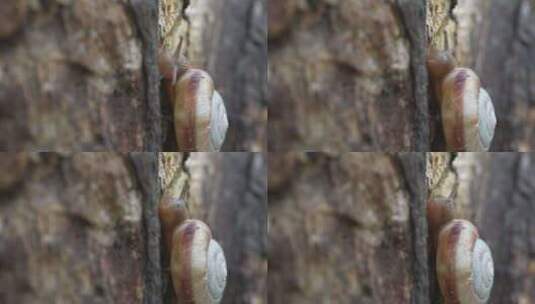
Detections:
[0, 153, 267, 304]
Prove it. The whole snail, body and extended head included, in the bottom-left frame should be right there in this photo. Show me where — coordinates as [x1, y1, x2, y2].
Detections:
[158, 178, 227, 304]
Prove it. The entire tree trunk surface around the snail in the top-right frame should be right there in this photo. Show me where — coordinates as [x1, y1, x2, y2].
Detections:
[268, 0, 535, 152]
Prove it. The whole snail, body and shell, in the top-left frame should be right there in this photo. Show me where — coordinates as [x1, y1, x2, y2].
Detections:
[158, 51, 228, 152]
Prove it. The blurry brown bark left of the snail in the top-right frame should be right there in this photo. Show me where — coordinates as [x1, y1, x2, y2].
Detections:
[268, 0, 429, 151]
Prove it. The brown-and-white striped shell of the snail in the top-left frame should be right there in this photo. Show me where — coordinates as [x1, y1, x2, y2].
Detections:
[174, 69, 228, 151]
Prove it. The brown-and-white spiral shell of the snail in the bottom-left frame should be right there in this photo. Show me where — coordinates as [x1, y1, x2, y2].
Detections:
[171, 220, 227, 304]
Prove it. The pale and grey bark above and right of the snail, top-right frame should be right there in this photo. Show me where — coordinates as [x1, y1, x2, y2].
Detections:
[427, 0, 535, 151]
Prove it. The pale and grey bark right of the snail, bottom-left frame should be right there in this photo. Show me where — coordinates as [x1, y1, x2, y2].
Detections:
[160, 153, 267, 303]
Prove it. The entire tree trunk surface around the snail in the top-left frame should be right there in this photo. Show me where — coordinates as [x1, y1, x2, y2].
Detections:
[0, 0, 267, 151]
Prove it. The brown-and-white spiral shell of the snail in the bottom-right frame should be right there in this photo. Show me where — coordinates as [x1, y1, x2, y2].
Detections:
[437, 220, 494, 304]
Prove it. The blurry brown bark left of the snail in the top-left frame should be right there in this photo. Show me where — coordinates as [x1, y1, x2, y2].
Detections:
[0, 0, 161, 151]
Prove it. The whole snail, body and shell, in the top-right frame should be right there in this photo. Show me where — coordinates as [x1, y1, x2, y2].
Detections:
[427, 49, 496, 151]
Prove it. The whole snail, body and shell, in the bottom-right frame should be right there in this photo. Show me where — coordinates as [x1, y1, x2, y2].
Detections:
[427, 198, 494, 304]
